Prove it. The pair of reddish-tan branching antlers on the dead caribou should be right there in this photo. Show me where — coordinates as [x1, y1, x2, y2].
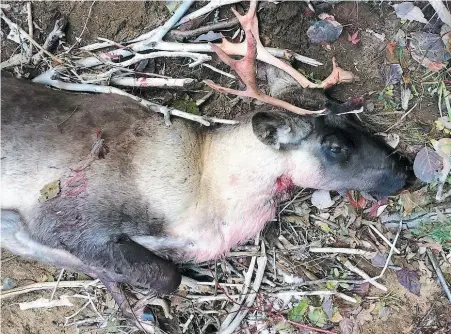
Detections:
[205, 0, 362, 115]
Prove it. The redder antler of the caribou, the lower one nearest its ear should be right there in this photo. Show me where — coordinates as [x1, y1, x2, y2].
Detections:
[204, 30, 325, 115]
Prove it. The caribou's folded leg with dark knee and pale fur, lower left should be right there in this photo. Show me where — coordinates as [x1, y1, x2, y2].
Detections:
[0, 210, 181, 328]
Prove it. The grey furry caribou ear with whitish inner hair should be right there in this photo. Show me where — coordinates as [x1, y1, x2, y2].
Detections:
[252, 112, 312, 150]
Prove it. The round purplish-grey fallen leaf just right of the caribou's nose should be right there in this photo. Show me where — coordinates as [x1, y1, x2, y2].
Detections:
[413, 147, 443, 183]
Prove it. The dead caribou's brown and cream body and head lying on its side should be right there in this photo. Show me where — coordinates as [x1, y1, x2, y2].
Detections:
[1, 0, 414, 324]
